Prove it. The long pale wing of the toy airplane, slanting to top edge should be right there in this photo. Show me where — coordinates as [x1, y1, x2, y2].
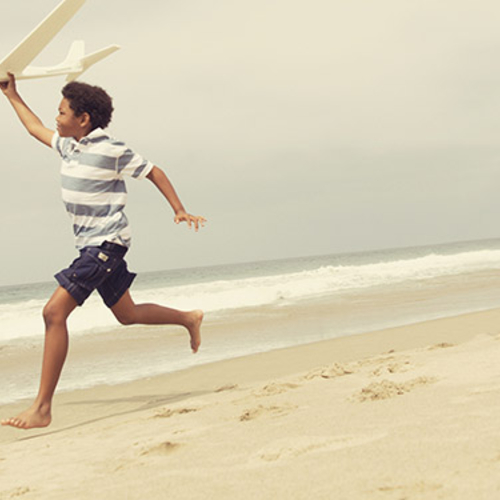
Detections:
[0, 0, 85, 79]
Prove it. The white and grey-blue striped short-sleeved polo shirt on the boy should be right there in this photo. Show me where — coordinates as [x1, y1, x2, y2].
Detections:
[52, 128, 153, 249]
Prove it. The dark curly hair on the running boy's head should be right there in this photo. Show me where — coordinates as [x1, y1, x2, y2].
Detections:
[61, 82, 113, 130]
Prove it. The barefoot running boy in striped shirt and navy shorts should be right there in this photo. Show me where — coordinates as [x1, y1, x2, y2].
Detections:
[0, 75, 205, 429]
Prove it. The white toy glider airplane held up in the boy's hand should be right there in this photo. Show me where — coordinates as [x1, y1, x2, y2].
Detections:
[0, 0, 120, 82]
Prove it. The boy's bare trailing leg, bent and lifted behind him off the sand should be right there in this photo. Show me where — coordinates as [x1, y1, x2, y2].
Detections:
[111, 290, 203, 352]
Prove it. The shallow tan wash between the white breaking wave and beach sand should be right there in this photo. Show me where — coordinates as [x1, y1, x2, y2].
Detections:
[0, 273, 498, 407]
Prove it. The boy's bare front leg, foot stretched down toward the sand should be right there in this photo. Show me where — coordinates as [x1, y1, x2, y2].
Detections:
[2, 287, 77, 429]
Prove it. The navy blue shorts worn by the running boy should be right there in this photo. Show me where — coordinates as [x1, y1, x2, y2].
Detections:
[54, 241, 136, 307]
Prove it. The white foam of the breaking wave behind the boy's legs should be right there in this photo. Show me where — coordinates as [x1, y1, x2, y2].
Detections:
[0, 249, 500, 342]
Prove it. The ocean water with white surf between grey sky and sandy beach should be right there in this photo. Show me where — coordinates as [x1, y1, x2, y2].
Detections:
[0, 239, 500, 403]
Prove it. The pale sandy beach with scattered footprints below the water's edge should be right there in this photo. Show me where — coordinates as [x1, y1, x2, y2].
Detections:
[0, 309, 500, 500]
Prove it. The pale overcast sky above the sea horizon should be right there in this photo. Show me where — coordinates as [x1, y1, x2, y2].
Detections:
[0, 0, 500, 285]
